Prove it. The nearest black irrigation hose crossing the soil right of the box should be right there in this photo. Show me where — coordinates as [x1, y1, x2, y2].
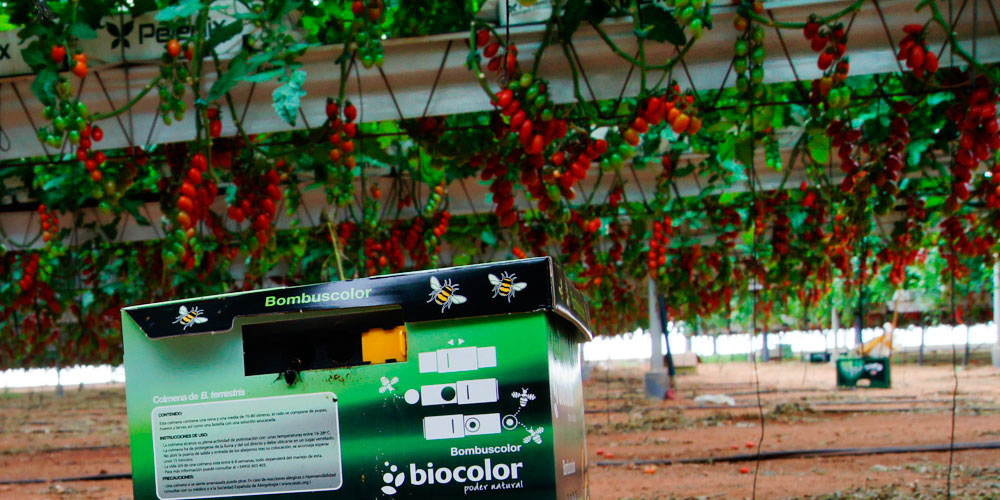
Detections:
[594, 441, 1000, 466]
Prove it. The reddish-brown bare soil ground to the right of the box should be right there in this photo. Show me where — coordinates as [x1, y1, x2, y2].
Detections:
[584, 363, 1000, 499]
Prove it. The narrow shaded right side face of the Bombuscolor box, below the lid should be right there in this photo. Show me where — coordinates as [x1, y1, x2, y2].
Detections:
[549, 315, 589, 500]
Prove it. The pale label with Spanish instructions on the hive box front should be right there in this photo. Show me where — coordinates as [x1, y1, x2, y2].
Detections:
[152, 392, 343, 500]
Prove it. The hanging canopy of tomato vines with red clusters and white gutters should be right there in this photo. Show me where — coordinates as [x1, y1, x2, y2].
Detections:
[0, 0, 1000, 369]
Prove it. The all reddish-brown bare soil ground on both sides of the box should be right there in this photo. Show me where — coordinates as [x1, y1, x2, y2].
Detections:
[0, 363, 1000, 500]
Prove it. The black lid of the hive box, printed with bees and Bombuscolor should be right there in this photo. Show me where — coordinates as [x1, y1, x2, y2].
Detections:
[123, 257, 593, 340]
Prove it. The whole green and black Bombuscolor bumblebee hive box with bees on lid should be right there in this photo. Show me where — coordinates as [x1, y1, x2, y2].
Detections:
[122, 258, 591, 500]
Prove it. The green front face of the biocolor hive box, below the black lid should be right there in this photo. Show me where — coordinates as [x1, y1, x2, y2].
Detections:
[123, 312, 556, 500]
